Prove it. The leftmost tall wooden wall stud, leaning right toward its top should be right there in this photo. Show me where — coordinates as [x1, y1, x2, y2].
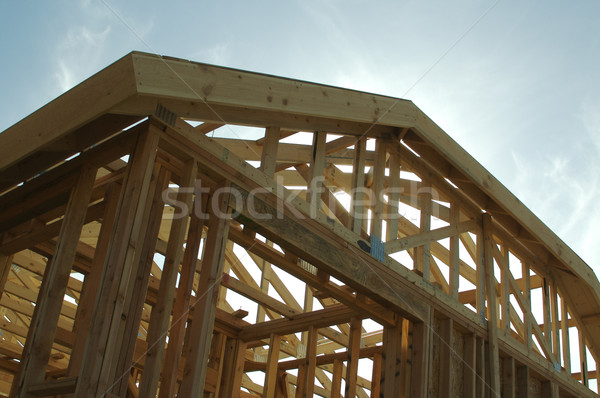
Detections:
[11, 165, 97, 397]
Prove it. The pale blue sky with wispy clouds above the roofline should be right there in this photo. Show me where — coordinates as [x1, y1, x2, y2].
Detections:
[0, 0, 600, 274]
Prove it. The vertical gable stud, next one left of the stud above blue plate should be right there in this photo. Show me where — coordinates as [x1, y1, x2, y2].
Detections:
[348, 137, 367, 235]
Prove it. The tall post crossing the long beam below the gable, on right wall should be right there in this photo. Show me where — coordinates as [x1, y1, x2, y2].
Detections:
[483, 214, 500, 394]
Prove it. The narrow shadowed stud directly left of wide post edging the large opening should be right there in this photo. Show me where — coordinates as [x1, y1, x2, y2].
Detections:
[159, 190, 209, 398]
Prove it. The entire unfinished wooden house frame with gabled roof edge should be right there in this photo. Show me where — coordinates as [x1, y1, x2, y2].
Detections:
[0, 52, 600, 398]
